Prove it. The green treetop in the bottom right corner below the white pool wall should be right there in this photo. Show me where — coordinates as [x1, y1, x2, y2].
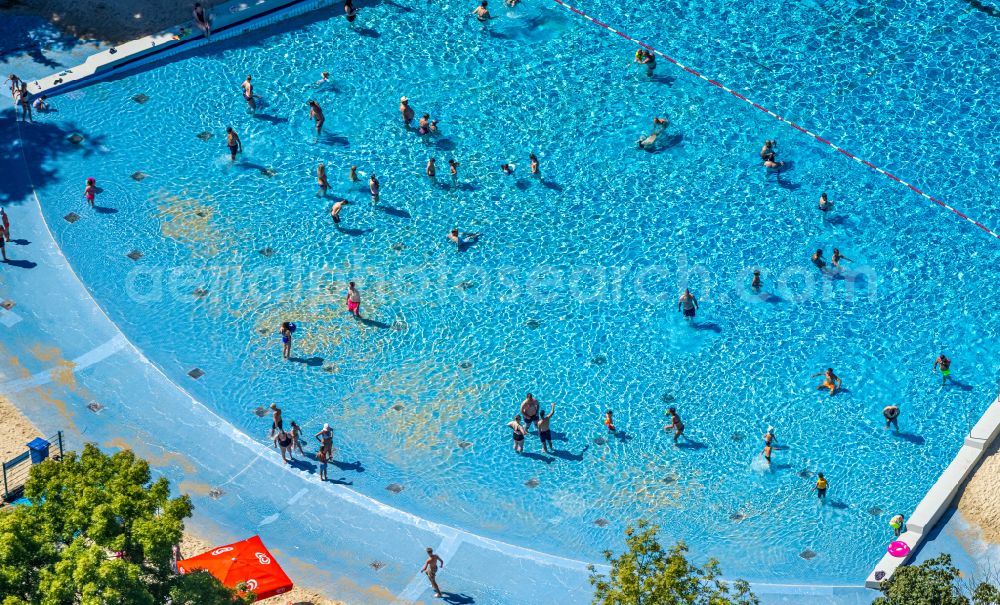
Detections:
[872, 554, 1000, 605]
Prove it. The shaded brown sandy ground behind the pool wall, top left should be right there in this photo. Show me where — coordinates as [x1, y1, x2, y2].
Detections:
[6, 0, 229, 44]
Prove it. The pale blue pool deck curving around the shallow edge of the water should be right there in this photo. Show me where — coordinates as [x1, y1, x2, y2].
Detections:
[0, 5, 1000, 604]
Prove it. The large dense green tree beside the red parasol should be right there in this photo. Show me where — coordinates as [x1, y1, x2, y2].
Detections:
[0, 445, 252, 605]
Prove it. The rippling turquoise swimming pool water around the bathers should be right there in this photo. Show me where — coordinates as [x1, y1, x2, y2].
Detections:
[22, 1, 1000, 583]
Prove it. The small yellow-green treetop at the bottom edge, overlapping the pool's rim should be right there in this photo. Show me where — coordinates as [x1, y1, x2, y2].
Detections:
[590, 521, 759, 605]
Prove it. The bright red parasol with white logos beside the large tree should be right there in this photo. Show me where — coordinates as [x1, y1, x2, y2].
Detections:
[177, 536, 292, 601]
